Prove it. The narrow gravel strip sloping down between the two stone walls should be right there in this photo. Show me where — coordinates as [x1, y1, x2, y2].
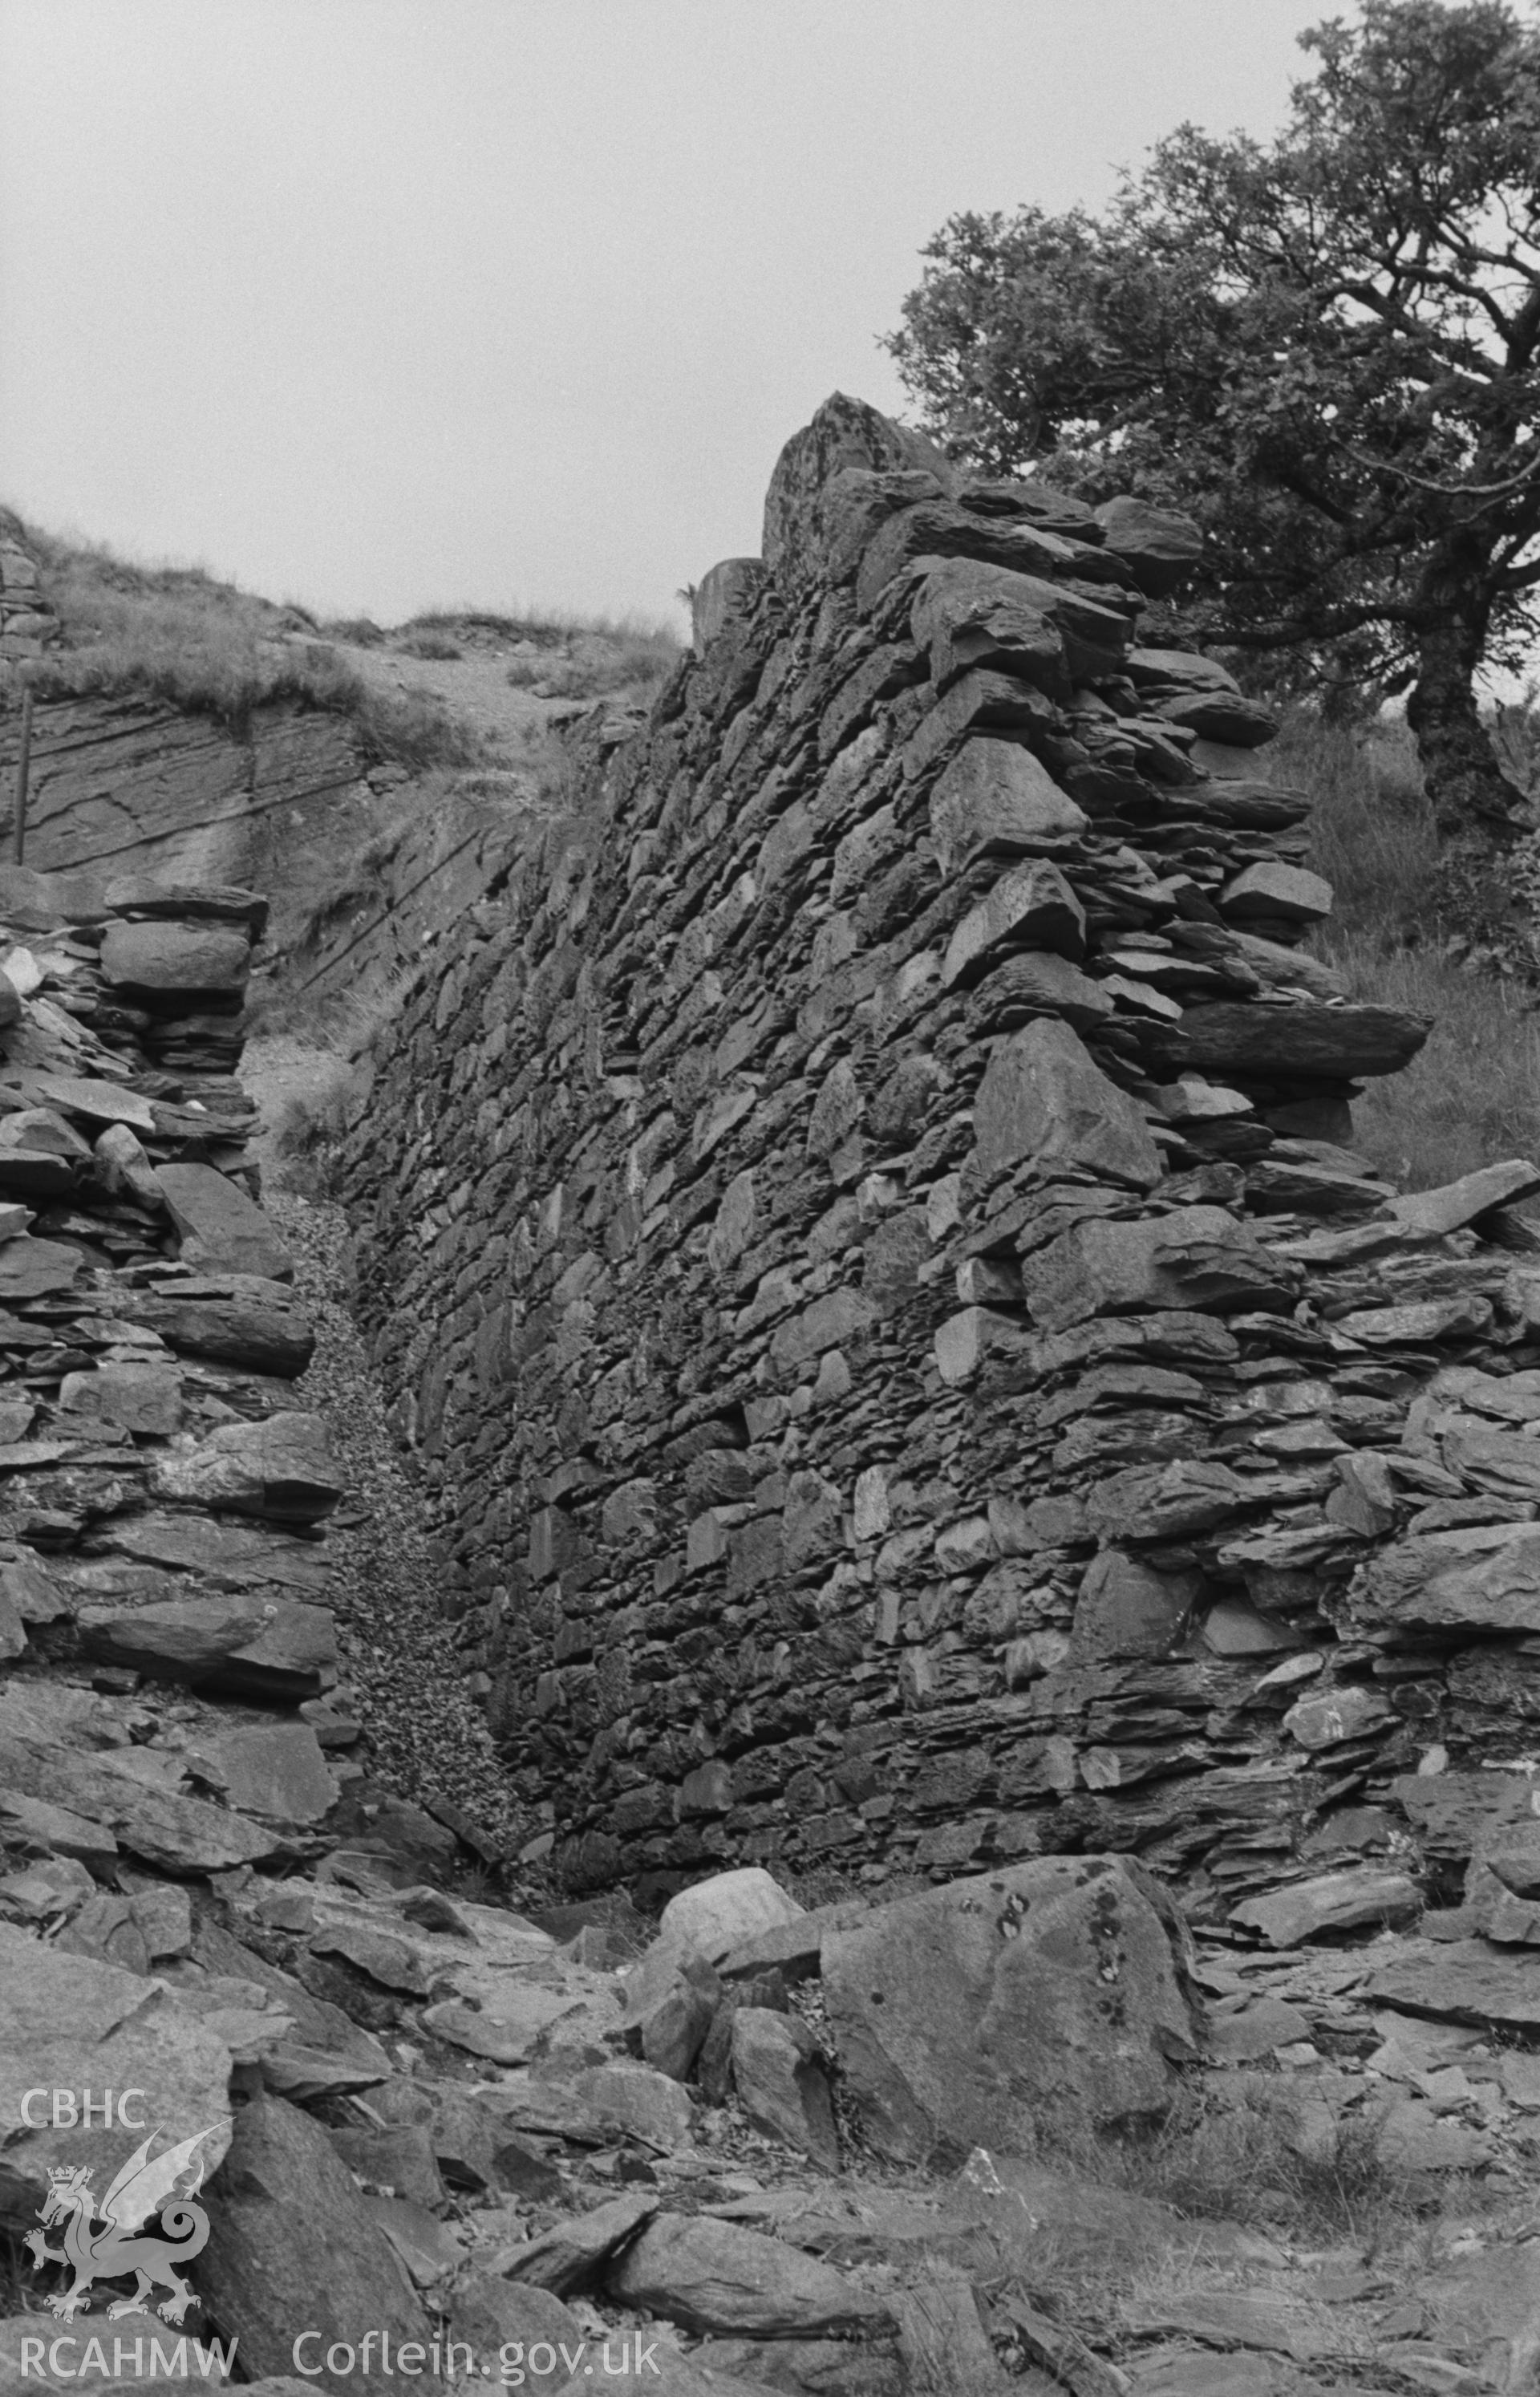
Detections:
[263, 1189, 529, 1853]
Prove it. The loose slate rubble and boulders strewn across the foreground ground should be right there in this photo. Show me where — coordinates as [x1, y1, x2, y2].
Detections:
[14, 1831, 1540, 2397]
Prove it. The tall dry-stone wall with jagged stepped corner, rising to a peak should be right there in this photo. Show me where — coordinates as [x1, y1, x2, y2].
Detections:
[345, 398, 1540, 1922]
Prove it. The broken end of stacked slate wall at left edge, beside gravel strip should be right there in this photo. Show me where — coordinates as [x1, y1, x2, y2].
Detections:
[0, 868, 373, 1783]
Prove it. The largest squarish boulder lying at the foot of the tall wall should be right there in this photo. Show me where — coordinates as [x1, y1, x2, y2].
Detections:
[824, 1856, 1198, 2164]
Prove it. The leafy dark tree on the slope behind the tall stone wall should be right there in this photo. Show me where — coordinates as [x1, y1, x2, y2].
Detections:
[889, 0, 1540, 817]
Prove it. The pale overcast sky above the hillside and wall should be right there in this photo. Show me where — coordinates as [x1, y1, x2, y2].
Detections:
[0, 0, 1351, 623]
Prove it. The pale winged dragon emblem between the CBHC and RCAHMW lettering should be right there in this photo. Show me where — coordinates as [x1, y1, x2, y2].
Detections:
[24, 2126, 224, 2322]
